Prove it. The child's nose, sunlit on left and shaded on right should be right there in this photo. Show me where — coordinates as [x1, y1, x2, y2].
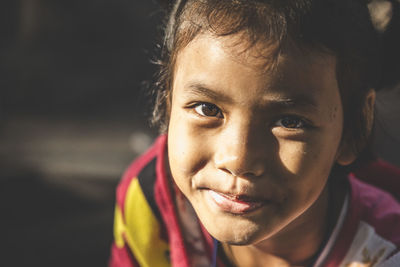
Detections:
[214, 120, 268, 178]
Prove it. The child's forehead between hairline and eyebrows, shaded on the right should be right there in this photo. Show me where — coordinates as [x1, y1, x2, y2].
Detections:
[173, 34, 338, 107]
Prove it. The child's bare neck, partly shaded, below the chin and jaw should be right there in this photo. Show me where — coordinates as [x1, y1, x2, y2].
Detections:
[223, 179, 345, 266]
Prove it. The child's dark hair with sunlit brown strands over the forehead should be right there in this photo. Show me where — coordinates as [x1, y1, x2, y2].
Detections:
[152, 0, 398, 172]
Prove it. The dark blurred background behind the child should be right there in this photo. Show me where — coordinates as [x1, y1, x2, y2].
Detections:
[0, 0, 400, 266]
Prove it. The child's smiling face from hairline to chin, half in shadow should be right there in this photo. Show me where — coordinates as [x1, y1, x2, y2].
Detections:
[168, 34, 343, 245]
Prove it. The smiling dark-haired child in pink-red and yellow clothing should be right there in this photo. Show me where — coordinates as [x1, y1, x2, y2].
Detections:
[110, 0, 400, 266]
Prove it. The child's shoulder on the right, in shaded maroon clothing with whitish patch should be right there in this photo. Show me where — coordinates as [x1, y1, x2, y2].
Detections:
[332, 175, 400, 266]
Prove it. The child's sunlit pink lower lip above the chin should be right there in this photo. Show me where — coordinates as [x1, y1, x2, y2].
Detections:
[206, 190, 266, 214]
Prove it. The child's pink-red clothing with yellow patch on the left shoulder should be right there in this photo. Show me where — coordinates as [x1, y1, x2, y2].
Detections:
[110, 135, 400, 267]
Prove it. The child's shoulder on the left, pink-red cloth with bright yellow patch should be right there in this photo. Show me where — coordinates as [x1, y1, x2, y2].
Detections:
[111, 136, 170, 266]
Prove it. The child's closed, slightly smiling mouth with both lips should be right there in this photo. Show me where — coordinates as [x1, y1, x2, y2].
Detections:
[205, 189, 269, 214]
